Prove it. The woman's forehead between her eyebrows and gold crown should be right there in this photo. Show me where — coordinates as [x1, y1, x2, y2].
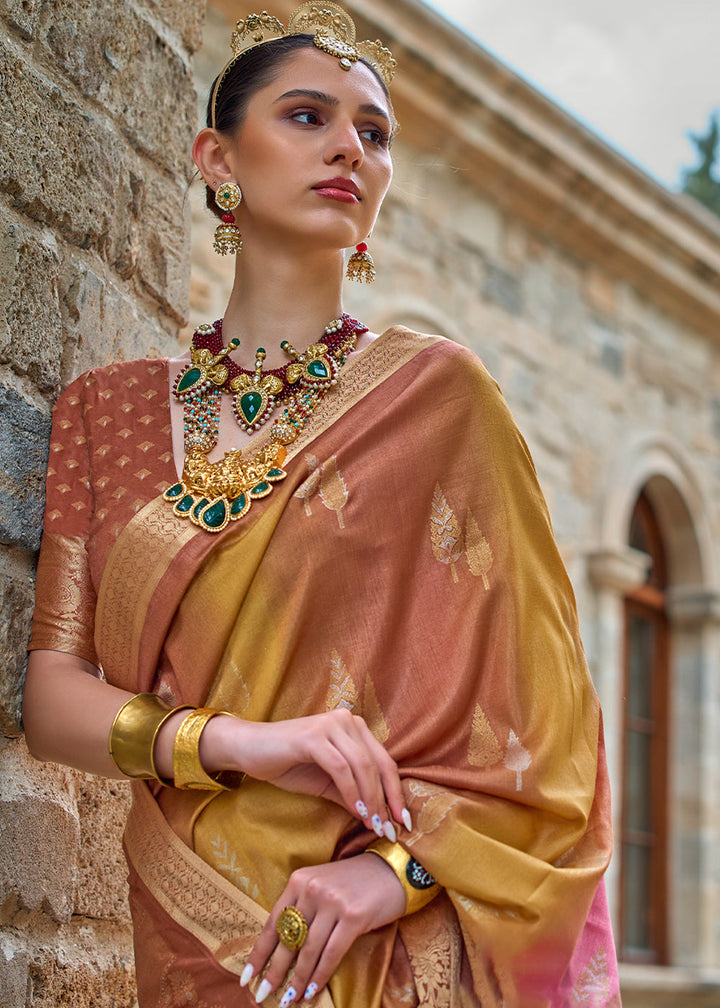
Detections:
[251, 46, 392, 118]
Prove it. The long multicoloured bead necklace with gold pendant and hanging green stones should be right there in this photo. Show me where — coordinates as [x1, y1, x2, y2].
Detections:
[162, 321, 358, 532]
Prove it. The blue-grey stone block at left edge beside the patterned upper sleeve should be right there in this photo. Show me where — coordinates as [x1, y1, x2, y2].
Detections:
[0, 384, 50, 549]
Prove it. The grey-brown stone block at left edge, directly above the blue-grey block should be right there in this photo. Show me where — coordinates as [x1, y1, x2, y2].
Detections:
[0, 213, 63, 392]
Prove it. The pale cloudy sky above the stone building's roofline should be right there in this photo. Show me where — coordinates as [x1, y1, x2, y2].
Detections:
[426, 0, 720, 190]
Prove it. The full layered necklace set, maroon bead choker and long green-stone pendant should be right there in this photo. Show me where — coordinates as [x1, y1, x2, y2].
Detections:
[162, 316, 367, 532]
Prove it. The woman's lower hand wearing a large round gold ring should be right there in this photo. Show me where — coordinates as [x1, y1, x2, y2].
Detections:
[241, 854, 405, 1008]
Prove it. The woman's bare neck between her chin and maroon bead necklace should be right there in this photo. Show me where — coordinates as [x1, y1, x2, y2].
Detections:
[223, 239, 343, 370]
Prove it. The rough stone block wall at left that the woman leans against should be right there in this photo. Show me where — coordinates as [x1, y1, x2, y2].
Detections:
[0, 0, 205, 1008]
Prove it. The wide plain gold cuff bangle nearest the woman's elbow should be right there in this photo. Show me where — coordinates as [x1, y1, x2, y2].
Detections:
[108, 694, 187, 785]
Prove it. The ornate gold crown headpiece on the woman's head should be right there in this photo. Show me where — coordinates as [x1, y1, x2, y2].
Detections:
[211, 0, 396, 129]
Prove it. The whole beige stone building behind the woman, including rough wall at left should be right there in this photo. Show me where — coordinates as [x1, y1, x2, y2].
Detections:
[0, 0, 720, 1008]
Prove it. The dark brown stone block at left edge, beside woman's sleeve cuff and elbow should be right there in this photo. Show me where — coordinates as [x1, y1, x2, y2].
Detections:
[0, 572, 34, 738]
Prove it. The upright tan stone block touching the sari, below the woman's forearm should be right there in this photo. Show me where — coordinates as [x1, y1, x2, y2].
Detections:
[75, 776, 130, 923]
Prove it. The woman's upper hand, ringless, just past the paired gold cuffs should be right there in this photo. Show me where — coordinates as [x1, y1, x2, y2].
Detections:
[200, 708, 410, 841]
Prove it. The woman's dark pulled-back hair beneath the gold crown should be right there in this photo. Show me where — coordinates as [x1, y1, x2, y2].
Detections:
[201, 35, 392, 217]
